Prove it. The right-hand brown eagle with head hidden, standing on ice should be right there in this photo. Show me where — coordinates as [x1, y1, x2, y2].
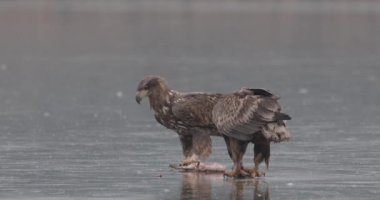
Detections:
[213, 88, 290, 176]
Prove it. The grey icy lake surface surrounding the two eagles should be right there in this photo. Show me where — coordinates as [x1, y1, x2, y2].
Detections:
[0, 0, 380, 200]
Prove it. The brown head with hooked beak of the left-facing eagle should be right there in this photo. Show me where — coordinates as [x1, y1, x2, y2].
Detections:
[136, 75, 167, 104]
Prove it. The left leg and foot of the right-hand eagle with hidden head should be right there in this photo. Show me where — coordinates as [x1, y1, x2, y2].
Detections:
[224, 137, 250, 177]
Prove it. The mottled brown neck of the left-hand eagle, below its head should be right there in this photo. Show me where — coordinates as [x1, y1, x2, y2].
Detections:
[149, 85, 177, 114]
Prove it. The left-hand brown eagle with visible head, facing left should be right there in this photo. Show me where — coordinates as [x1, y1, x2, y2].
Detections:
[136, 76, 222, 164]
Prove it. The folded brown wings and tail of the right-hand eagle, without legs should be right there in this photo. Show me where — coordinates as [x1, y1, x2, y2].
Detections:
[212, 89, 290, 141]
